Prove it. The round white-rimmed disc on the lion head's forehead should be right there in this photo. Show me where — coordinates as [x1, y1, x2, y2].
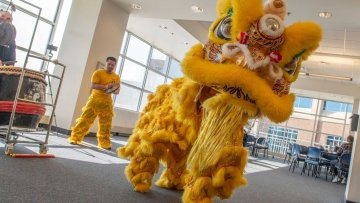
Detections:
[259, 14, 285, 39]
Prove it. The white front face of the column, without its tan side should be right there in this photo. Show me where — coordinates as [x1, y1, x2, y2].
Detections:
[53, 0, 102, 129]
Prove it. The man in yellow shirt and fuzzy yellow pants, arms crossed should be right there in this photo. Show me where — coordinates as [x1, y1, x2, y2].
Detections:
[69, 57, 120, 150]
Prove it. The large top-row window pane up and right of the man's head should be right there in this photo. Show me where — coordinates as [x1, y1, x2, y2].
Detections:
[126, 35, 150, 65]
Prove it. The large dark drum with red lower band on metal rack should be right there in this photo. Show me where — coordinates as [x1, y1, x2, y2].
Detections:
[0, 66, 47, 129]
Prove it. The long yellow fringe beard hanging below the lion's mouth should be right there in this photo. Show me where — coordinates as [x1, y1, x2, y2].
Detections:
[188, 93, 256, 171]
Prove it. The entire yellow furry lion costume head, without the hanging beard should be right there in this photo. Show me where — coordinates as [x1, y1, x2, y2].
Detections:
[182, 0, 322, 122]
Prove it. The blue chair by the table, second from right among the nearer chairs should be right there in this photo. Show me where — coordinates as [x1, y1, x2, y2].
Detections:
[301, 147, 321, 179]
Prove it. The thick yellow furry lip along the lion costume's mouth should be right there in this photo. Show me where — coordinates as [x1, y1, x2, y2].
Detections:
[182, 44, 295, 122]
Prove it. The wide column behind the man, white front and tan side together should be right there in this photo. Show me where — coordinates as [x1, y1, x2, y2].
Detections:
[56, 0, 129, 130]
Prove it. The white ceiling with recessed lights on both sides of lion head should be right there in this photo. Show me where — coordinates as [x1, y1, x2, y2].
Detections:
[113, 0, 360, 101]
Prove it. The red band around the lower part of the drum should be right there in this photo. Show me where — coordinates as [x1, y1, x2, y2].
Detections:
[0, 101, 46, 116]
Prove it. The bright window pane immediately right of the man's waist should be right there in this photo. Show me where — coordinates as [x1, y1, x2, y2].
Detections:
[115, 85, 140, 111]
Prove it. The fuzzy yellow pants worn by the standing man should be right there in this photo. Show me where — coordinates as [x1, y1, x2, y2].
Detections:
[69, 95, 113, 149]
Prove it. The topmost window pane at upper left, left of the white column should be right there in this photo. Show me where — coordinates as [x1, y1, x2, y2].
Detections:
[13, 0, 59, 21]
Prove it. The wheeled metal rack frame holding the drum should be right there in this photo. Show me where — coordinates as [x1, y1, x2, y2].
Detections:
[0, 0, 66, 157]
